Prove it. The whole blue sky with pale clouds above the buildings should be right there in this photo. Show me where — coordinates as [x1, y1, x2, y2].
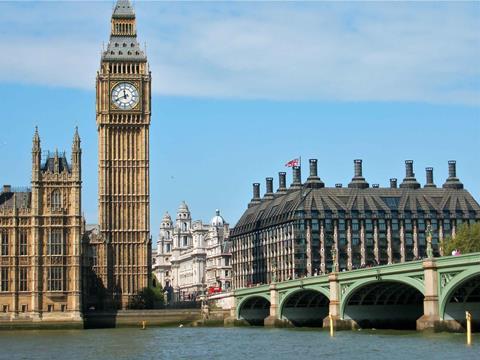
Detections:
[0, 1, 480, 245]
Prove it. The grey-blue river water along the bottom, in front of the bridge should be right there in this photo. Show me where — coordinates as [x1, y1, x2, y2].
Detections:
[0, 327, 480, 360]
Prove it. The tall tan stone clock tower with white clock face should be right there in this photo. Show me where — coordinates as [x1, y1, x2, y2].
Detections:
[96, 0, 151, 308]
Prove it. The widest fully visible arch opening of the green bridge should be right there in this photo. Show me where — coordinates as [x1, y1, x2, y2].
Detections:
[340, 277, 424, 329]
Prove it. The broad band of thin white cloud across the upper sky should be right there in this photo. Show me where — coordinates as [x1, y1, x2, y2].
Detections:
[0, 3, 480, 105]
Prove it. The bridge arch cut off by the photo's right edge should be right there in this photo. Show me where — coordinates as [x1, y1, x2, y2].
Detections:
[439, 267, 480, 331]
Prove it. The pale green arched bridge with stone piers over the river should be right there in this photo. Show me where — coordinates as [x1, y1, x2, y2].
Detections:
[225, 253, 480, 331]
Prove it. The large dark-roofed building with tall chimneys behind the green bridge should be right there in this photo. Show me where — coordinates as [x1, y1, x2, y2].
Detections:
[231, 159, 480, 288]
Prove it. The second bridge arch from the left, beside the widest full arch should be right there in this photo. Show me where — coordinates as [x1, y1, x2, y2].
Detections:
[279, 287, 330, 327]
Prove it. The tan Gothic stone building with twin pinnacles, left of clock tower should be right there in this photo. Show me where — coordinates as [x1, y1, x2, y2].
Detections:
[0, 131, 83, 322]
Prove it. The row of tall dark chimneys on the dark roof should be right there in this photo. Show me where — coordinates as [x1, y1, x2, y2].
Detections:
[251, 159, 463, 204]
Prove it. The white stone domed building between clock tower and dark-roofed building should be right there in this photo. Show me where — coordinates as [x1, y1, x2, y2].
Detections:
[152, 202, 232, 301]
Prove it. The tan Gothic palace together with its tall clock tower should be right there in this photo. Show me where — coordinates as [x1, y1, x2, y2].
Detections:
[0, 0, 151, 322]
